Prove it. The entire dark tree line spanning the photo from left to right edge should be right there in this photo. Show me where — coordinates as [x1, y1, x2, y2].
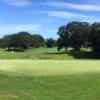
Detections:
[0, 21, 100, 52]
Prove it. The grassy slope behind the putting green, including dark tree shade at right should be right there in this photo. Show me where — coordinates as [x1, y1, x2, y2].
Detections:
[0, 48, 100, 60]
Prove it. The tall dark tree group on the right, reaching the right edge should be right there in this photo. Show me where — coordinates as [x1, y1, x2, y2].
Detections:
[57, 21, 100, 52]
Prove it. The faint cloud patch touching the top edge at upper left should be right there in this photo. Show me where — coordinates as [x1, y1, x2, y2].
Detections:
[3, 0, 30, 7]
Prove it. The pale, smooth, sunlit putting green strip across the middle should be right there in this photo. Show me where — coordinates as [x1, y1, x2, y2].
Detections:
[0, 60, 100, 76]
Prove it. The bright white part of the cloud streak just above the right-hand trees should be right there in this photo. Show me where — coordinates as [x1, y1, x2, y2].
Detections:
[47, 11, 100, 23]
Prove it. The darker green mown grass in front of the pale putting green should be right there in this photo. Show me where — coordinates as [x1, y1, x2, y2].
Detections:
[0, 73, 100, 100]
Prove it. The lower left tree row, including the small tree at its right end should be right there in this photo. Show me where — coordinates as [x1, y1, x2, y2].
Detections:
[0, 32, 56, 51]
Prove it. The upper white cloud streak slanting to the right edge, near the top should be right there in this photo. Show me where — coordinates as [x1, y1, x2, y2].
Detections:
[43, 1, 100, 11]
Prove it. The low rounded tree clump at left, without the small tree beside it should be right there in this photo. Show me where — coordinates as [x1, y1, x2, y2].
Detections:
[1, 32, 45, 50]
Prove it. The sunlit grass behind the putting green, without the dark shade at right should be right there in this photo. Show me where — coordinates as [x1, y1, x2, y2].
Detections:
[0, 48, 74, 59]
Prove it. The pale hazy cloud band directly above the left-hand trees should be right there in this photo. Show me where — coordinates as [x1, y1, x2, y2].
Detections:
[0, 24, 41, 35]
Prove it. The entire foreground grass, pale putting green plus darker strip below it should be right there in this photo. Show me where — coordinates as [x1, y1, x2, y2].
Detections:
[0, 60, 100, 100]
